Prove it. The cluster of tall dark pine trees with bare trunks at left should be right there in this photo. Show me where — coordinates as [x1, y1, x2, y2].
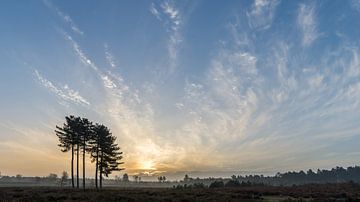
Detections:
[55, 116, 124, 189]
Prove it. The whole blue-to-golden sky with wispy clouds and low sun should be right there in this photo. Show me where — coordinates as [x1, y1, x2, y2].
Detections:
[0, 0, 360, 180]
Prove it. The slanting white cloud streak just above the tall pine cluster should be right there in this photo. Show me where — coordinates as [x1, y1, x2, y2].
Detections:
[34, 70, 90, 105]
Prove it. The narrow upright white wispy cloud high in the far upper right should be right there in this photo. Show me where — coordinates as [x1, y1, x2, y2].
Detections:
[297, 4, 319, 46]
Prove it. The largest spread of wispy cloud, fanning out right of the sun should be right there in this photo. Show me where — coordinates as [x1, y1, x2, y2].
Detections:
[169, 11, 360, 171]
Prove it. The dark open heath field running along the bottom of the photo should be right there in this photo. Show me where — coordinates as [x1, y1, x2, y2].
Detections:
[0, 184, 360, 201]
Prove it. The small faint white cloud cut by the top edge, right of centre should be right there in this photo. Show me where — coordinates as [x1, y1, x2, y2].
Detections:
[247, 0, 280, 29]
